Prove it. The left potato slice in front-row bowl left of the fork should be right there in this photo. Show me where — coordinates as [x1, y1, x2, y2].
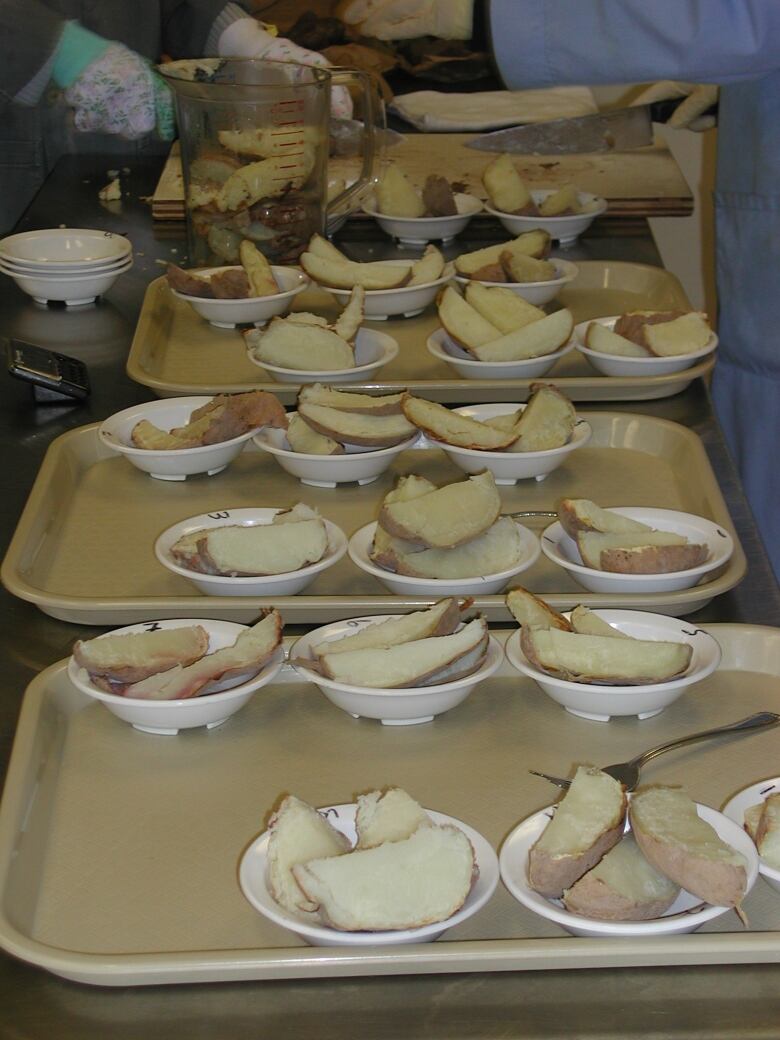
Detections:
[267, 795, 349, 913]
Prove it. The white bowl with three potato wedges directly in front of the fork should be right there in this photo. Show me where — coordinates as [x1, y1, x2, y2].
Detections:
[498, 803, 758, 938]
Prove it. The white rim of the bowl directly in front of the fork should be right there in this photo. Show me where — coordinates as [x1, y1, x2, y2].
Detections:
[498, 795, 758, 937]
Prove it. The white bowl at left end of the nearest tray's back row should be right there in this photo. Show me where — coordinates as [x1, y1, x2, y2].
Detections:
[68, 618, 284, 736]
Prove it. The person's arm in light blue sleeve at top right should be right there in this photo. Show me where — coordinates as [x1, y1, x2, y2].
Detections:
[489, 0, 780, 89]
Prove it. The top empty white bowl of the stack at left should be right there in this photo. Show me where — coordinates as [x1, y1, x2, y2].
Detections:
[0, 228, 132, 272]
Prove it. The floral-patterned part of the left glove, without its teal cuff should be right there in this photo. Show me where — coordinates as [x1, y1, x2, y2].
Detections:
[64, 44, 174, 140]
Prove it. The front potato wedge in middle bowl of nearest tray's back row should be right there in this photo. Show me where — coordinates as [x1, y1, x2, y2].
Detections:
[309, 618, 488, 690]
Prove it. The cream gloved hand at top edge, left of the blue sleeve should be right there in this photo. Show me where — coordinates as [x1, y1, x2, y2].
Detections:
[340, 0, 474, 40]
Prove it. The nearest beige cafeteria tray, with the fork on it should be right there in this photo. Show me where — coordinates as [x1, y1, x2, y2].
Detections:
[0, 625, 780, 986]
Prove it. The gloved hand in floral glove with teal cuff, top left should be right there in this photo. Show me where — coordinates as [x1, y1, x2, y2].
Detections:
[52, 22, 174, 140]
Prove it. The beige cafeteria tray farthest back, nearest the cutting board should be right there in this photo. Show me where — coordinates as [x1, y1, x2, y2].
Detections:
[127, 260, 714, 404]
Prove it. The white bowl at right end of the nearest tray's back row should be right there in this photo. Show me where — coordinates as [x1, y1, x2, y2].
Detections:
[506, 610, 721, 722]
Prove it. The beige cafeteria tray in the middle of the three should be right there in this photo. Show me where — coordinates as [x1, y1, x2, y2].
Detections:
[2, 412, 746, 625]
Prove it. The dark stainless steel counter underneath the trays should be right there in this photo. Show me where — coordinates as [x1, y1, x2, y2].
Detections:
[0, 156, 780, 1040]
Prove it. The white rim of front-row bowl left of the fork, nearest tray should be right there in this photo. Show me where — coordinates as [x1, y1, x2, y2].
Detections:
[238, 802, 500, 946]
